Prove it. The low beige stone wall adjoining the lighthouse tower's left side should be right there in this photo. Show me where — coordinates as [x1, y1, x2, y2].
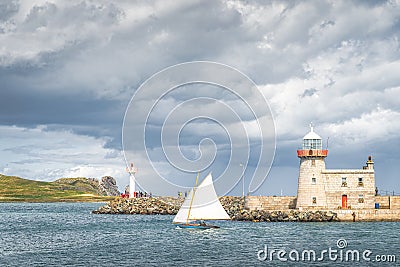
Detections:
[245, 196, 297, 210]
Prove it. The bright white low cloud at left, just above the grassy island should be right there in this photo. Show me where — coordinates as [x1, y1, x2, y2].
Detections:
[0, 126, 128, 191]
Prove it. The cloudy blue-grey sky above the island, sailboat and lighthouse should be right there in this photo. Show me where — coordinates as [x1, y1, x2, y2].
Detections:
[0, 0, 400, 195]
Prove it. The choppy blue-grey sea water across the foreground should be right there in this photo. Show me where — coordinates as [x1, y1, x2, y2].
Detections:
[0, 203, 400, 266]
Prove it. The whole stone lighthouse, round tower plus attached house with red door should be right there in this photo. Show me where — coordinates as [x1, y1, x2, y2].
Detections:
[296, 127, 375, 210]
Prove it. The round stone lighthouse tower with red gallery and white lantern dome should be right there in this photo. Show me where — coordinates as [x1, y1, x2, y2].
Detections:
[296, 125, 328, 209]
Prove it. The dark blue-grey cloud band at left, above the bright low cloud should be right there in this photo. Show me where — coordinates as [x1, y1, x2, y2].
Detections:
[0, 89, 126, 126]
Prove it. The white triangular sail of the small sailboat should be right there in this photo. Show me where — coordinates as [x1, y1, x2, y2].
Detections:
[173, 173, 230, 223]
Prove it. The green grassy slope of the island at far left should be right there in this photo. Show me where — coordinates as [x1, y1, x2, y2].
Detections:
[0, 174, 114, 202]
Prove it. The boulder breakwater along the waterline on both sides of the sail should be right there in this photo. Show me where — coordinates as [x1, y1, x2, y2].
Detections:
[92, 196, 339, 222]
